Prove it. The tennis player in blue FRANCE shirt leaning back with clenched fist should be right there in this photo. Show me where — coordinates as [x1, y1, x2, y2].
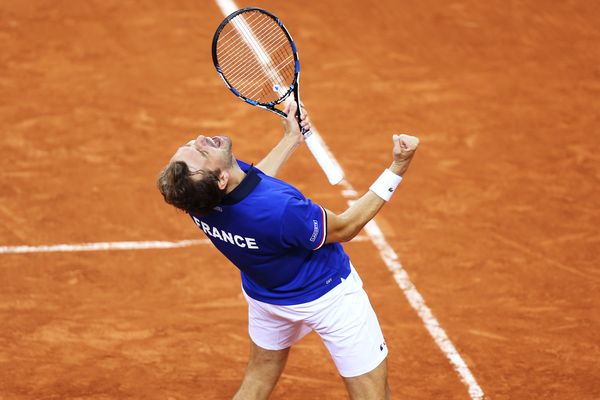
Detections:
[157, 101, 418, 399]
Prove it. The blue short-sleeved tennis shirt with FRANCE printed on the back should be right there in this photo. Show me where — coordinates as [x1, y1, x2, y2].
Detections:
[190, 161, 350, 305]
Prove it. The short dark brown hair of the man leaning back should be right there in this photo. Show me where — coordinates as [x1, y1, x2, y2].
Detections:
[156, 161, 225, 216]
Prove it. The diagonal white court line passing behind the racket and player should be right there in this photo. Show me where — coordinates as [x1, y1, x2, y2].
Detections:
[215, 0, 484, 400]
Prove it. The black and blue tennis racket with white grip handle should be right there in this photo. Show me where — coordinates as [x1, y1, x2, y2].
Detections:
[212, 7, 344, 185]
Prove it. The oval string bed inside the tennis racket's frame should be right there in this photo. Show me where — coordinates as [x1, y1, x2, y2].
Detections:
[217, 12, 295, 103]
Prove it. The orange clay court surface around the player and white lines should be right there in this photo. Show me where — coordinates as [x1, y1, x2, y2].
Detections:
[0, 0, 600, 400]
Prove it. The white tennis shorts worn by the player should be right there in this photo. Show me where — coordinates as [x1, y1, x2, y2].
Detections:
[242, 267, 388, 378]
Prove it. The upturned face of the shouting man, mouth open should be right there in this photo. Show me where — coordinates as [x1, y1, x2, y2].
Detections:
[171, 135, 234, 179]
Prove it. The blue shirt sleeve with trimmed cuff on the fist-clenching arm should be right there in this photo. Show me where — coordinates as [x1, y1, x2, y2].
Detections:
[281, 197, 327, 250]
